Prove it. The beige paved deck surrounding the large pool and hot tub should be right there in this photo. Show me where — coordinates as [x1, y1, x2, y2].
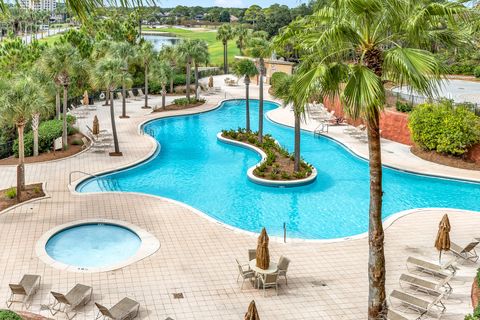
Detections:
[0, 77, 480, 320]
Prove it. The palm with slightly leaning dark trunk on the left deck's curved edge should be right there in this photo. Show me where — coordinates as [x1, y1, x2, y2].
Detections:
[91, 56, 125, 156]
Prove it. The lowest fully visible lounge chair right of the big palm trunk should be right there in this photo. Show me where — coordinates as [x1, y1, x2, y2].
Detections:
[389, 290, 446, 318]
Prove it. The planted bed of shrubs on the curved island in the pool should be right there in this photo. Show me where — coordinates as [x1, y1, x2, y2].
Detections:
[221, 128, 314, 181]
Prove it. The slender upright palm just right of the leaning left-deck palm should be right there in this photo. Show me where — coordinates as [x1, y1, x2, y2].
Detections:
[107, 42, 136, 119]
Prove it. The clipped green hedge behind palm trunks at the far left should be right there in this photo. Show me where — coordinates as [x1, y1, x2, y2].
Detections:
[13, 118, 76, 157]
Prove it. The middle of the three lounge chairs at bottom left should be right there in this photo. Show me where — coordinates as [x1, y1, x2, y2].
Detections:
[48, 284, 93, 319]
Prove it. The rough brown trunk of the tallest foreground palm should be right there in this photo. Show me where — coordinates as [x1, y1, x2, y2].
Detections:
[368, 111, 386, 320]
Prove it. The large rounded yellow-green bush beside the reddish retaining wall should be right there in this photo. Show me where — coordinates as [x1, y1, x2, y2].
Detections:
[408, 102, 480, 156]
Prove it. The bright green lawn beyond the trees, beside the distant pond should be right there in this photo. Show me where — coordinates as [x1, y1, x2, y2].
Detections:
[142, 27, 240, 66]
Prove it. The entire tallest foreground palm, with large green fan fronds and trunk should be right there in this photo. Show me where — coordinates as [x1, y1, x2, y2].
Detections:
[278, 0, 466, 320]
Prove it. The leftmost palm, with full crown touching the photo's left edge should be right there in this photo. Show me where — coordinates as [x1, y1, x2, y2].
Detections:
[0, 74, 45, 202]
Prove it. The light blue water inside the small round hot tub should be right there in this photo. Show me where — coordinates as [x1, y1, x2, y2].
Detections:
[45, 224, 141, 267]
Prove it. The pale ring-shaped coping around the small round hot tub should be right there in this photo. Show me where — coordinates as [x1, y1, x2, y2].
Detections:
[35, 218, 160, 273]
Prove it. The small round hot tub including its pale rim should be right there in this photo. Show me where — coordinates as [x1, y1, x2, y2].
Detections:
[37, 220, 160, 272]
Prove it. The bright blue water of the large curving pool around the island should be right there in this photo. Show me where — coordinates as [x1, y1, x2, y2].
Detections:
[78, 100, 480, 239]
